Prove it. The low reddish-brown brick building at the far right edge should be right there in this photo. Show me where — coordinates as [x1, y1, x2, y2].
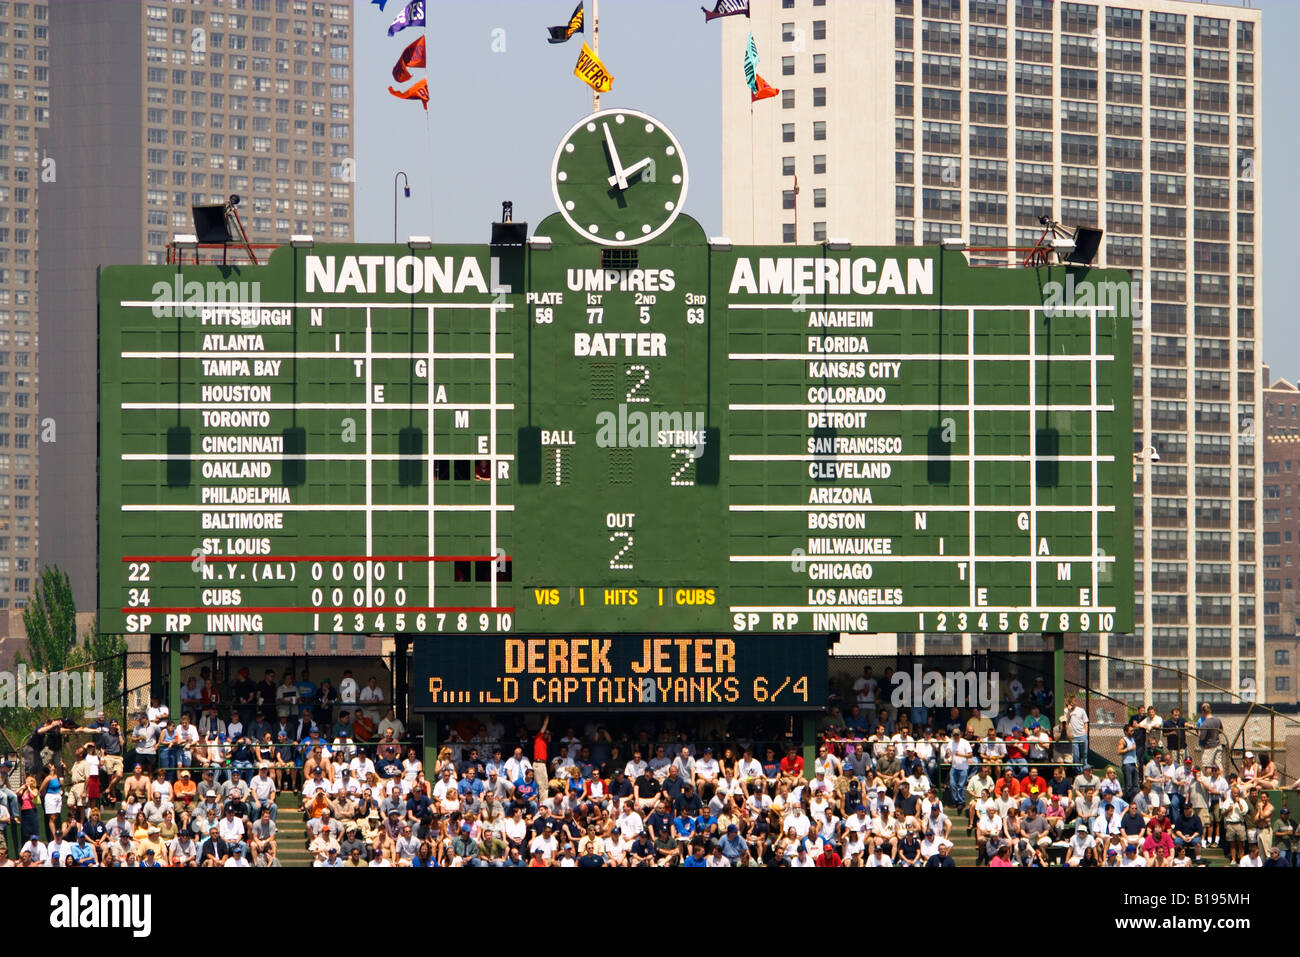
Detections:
[1260, 365, 1300, 705]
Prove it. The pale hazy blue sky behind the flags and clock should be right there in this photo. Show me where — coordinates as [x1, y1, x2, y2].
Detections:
[354, 0, 1300, 381]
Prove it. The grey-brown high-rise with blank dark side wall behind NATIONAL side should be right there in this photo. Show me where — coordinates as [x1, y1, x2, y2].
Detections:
[38, 0, 355, 609]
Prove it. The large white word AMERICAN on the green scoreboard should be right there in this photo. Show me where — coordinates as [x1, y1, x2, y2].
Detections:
[728, 256, 935, 295]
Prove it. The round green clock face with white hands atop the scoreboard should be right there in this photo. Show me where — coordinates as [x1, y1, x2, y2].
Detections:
[551, 109, 689, 246]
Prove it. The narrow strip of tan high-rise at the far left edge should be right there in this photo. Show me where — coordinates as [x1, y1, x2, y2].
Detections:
[0, 3, 49, 613]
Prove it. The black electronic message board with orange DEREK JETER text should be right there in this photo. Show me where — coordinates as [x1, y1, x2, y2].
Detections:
[411, 635, 827, 711]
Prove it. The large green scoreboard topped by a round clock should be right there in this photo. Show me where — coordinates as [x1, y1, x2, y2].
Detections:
[99, 111, 1132, 642]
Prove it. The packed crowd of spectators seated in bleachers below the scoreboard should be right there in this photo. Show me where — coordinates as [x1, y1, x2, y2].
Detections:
[0, 668, 1300, 867]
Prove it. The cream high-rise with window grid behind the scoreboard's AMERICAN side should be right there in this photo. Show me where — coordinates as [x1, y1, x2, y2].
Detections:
[722, 0, 1264, 709]
